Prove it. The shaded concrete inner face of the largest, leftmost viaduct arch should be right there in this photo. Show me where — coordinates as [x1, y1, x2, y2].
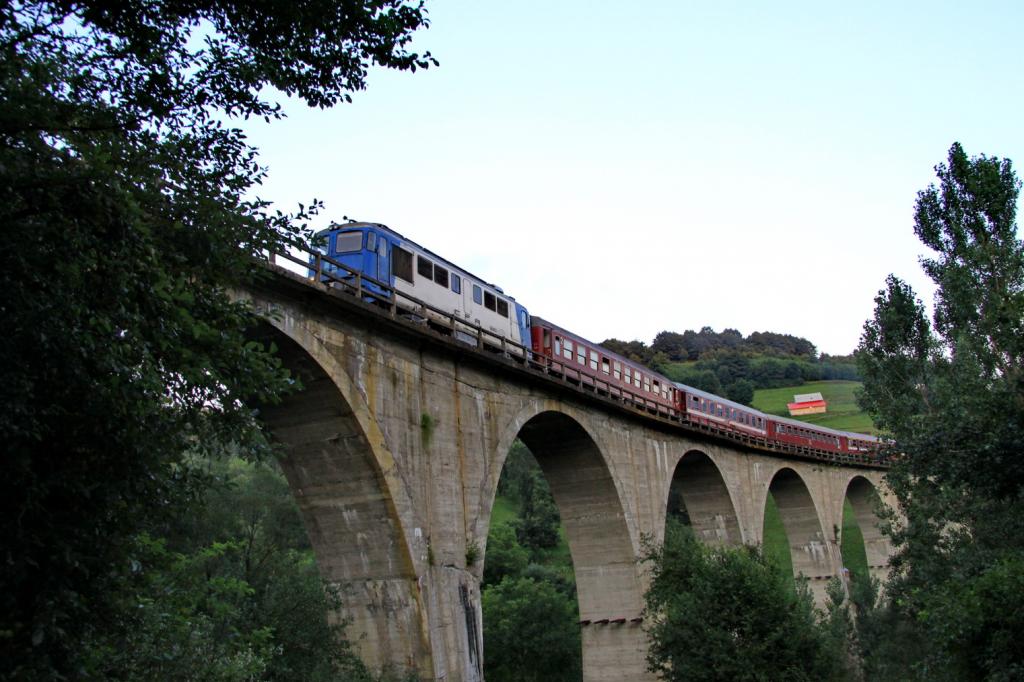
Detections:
[251, 322, 432, 674]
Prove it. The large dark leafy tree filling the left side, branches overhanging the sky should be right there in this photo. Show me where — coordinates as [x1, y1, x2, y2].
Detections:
[0, 0, 432, 679]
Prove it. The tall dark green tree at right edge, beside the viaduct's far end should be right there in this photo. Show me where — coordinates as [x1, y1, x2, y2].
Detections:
[857, 143, 1024, 680]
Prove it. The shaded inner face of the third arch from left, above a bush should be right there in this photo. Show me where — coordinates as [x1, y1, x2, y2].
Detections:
[666, 450, 743, 546]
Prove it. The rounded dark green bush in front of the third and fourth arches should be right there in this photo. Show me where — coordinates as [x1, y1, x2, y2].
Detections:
[644, 522, 844, 681]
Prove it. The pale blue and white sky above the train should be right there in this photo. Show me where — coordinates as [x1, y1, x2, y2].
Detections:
[246, 0, 1024, 354]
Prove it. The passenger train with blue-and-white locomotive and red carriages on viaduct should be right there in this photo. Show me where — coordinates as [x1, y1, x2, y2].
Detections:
[309, 222, 882, 457]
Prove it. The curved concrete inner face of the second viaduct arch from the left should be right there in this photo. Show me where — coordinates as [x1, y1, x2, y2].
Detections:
[484, 410, 645, 680]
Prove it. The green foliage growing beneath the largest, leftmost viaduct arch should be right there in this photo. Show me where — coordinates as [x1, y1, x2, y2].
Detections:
[79, 460, 369, 681]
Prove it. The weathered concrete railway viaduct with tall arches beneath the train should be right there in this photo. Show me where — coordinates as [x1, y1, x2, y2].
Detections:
[238, 272, 889, 681]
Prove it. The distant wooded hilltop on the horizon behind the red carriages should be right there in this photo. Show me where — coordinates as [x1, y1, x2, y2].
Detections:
[601, 327, 860, 404]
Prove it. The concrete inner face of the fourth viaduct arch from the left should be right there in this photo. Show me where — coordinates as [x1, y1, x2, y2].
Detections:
[762, 467, 835, 603]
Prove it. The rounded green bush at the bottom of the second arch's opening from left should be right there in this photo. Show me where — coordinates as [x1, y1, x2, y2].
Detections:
[483, 578, 582, 682]
